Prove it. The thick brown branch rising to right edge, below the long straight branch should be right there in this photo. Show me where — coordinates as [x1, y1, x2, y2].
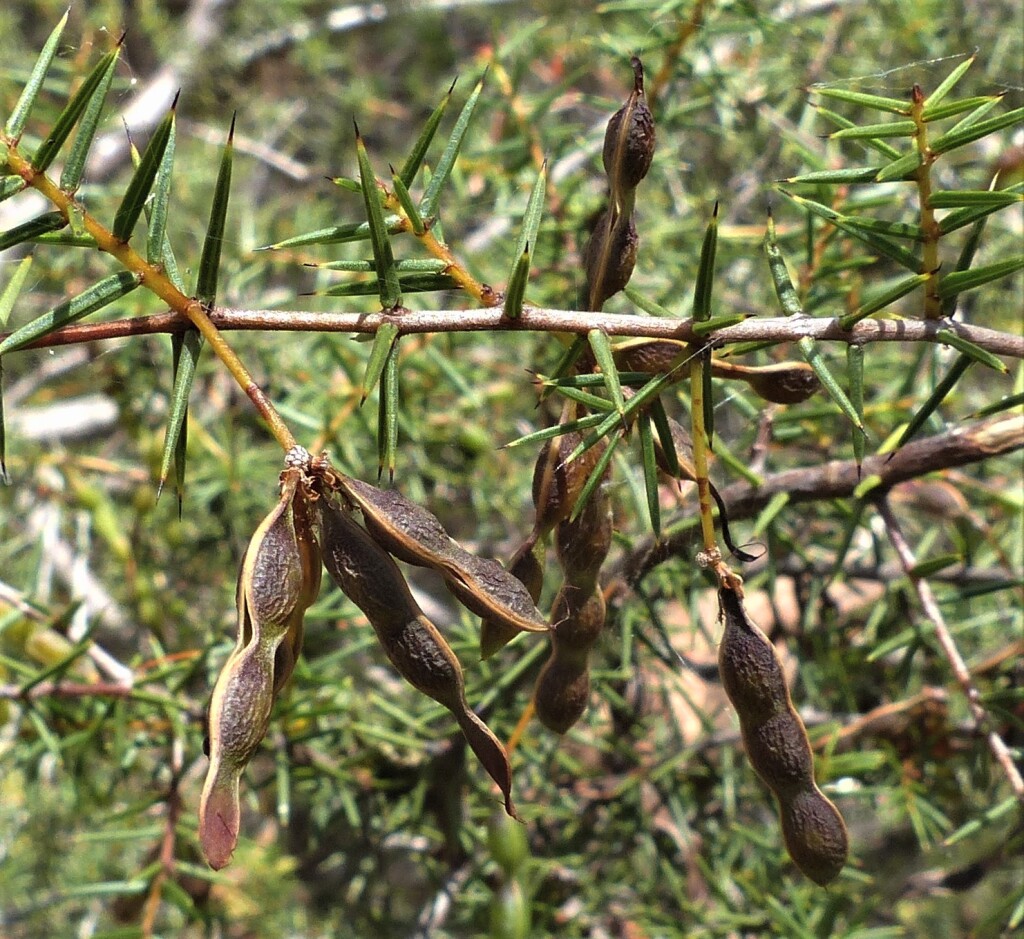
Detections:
[616, 415, 1024, 584]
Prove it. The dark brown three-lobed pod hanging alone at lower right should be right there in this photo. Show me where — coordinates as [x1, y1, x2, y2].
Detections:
[718, 588, 849, 887]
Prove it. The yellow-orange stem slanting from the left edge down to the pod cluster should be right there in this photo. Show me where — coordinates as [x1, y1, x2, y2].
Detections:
[5, 141, 295, 452]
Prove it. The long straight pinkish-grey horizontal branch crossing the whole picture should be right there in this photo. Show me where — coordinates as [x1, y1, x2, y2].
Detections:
[8, 306, 1024, 358]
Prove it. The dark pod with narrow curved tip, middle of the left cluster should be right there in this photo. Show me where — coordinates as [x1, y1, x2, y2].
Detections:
[317, 499, 515, 816]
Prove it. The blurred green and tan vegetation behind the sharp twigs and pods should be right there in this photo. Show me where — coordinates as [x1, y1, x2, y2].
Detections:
[0, 0, 1024, 939]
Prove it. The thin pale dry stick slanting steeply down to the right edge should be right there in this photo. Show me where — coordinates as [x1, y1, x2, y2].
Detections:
[874, 496, 1024, 803]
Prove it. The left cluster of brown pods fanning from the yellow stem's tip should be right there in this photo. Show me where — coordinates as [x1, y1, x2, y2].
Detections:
[200, 447, 549, 868]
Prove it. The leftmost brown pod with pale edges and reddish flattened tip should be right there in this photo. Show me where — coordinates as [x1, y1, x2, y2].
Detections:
[200, 466, 321, 868]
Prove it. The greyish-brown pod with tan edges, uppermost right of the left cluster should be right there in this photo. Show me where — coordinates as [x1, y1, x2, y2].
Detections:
[339, 477, 548, 633]
